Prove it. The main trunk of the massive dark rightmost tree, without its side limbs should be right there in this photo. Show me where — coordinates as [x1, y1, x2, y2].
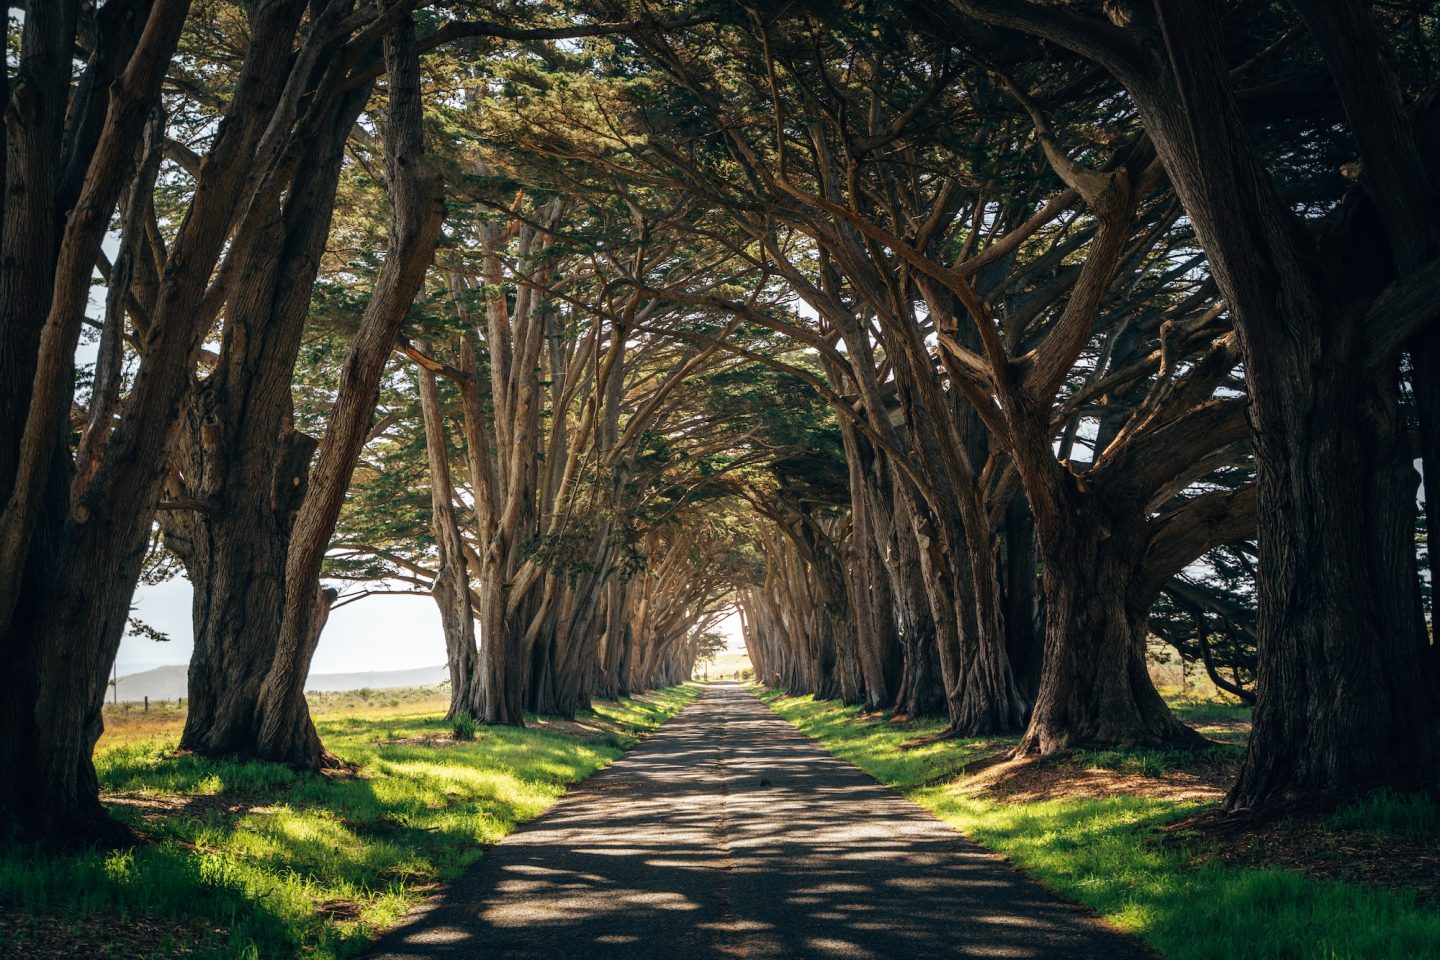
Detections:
[1133, 1, 1440, 810]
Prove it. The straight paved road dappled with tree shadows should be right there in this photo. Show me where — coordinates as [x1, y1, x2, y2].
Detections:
[373, 684, 1148, 960]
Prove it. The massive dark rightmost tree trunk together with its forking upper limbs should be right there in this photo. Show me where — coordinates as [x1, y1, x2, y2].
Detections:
[955, 0, 1440, 813]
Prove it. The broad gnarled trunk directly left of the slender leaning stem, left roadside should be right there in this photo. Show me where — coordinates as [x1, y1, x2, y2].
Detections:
[160, 67, 370, 757]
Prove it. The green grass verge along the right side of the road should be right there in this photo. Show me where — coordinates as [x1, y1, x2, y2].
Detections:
[759, 691, 1440, 960]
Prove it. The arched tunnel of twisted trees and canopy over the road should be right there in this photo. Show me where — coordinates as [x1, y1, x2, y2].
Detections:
[0, 0, 1440, 880]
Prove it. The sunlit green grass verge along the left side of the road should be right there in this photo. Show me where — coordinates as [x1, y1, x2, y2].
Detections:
[0, 684, 700, 960]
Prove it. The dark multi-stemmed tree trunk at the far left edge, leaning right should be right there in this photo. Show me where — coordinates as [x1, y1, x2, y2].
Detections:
[0, 0, 263, 842]
